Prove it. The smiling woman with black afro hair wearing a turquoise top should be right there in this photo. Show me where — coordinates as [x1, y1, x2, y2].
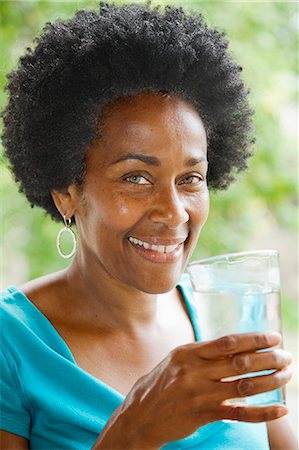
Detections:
[1, 4, 295, 450]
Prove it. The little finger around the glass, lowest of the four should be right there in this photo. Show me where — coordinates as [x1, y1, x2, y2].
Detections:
[219, 404, 288, 422]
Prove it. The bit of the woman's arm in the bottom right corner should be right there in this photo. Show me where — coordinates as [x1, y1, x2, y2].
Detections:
[267, 417, 299, 450]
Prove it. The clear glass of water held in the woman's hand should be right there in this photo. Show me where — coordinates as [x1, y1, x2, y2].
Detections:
[187, 250, 285, 405]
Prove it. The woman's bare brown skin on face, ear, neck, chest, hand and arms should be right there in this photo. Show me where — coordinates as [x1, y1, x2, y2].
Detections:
[1, 93, 296, 450]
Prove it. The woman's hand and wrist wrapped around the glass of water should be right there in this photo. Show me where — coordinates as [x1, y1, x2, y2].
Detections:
[93, 333, 291, 450]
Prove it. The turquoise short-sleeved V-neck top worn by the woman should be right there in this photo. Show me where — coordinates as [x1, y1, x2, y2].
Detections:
[0, 275, 269, 450]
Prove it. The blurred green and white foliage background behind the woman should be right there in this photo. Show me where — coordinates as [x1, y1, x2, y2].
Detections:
[0, 0, 298, 436]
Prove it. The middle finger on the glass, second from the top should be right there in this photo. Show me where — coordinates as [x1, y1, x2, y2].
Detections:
[208, 349, 292, 380]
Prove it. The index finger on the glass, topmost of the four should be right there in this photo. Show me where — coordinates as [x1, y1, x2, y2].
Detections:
[196, 332, 281, 359]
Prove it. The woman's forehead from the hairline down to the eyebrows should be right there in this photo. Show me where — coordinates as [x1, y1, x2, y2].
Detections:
[86, 92, 207, 172]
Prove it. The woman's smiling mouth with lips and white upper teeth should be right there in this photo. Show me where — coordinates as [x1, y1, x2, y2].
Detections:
[128, 236, 187, 263]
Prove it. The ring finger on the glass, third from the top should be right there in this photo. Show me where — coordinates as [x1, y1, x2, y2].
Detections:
[223, 367, 292, 399]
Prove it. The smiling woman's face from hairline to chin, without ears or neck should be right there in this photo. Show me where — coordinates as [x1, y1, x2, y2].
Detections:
[75, 92, 209, 293]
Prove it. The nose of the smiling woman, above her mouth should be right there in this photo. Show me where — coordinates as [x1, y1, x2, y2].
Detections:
[150, 187, 189, 229]
